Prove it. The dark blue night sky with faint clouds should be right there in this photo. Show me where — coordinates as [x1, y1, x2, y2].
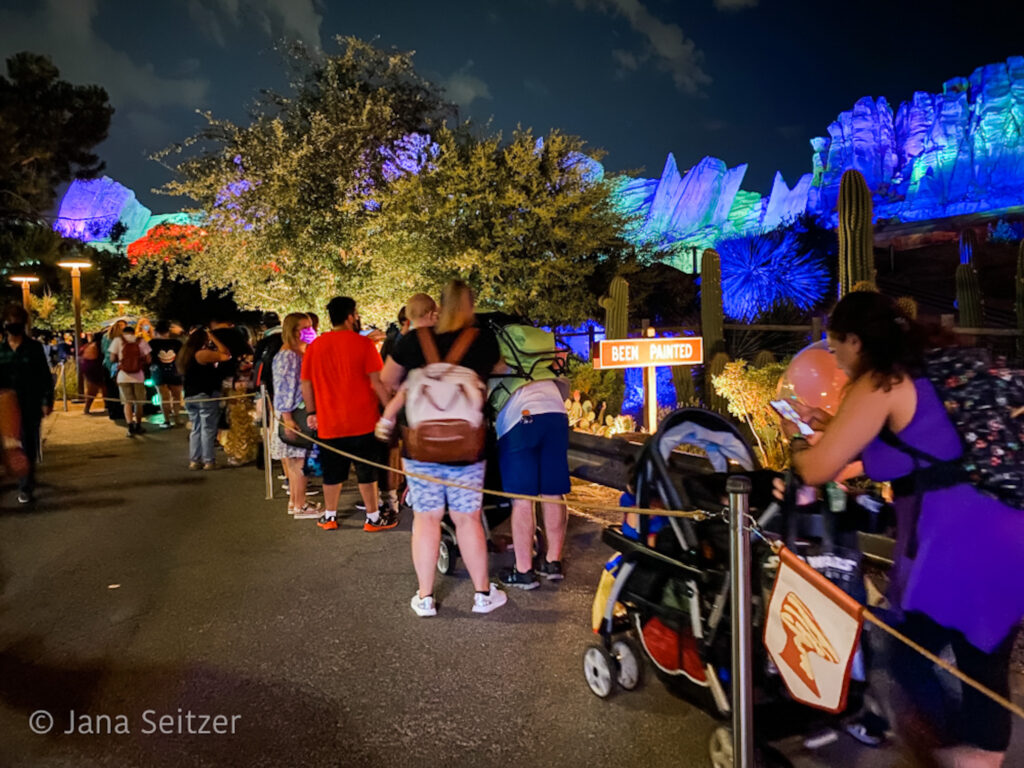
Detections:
[0, 0, 1024, 212]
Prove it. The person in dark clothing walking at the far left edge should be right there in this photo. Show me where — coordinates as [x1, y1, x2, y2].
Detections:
[0, 304, 53, 504]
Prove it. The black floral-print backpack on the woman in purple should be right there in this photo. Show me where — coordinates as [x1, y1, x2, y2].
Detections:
[882, 348, 1024, 509]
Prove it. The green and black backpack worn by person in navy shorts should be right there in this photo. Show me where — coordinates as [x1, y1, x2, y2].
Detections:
[487, 323, 568, 414]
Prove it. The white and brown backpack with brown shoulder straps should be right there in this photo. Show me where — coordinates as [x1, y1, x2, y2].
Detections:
[402, 328, 486, 464]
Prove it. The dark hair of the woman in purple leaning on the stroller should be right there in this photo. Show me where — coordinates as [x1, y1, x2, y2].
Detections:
[828, 291, 930, 392]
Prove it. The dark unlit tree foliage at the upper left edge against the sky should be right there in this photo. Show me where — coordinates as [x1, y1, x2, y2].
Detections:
[0, 52, 114, 225]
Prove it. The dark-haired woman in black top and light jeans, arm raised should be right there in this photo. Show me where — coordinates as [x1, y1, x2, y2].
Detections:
[177, 328, 231, 470]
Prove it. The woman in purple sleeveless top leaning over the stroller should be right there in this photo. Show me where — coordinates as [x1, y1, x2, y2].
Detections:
[782, 292, 1024, 768]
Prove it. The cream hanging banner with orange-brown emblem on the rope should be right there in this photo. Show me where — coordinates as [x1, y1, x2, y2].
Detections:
[764, 547, 864, 713]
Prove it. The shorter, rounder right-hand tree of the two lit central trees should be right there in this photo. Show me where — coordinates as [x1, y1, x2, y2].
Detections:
[357, 126, 636, 323]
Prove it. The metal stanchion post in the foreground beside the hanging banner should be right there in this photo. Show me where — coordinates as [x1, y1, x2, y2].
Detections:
[726, 475, 754, 768]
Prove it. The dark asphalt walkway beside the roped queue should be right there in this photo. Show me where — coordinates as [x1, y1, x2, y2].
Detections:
[0, 405, 1020, 768]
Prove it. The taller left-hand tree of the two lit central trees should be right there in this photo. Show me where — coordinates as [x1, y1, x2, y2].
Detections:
[158, 38, 449, 319]
